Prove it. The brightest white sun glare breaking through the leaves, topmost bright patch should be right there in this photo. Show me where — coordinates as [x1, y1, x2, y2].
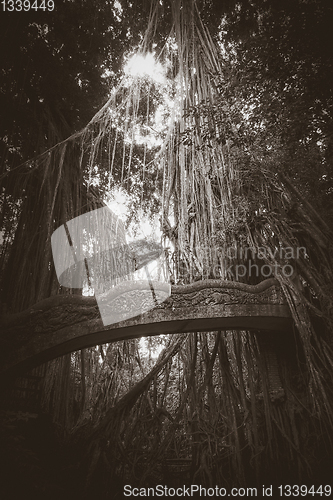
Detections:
[124, 52, 165, 83]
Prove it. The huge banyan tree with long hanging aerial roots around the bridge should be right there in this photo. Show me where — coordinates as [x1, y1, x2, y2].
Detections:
[0, 0, 333, 498]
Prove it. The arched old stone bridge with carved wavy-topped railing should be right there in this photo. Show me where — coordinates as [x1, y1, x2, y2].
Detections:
[0, 278, 292, 374]
